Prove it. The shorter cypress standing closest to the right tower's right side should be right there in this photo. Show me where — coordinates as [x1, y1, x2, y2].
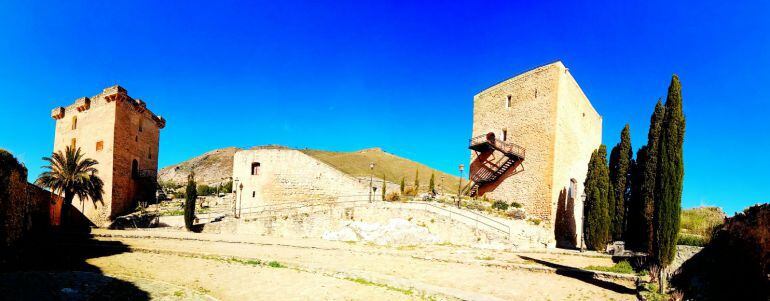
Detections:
[584, 145, 612, 250]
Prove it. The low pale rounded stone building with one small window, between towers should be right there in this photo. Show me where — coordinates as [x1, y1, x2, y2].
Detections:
[233, 147, 368, 208]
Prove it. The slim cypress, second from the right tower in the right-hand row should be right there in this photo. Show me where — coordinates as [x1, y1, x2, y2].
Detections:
[609, 124, 634, 240]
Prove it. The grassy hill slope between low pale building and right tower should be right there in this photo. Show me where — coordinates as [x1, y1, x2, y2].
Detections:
[302, 148, 459, 192]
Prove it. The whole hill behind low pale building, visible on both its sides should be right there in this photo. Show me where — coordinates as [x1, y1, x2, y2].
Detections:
[158, 146, 459, 193]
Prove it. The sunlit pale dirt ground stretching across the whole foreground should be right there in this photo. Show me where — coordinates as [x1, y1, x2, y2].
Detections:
[75, 231, 636, 300]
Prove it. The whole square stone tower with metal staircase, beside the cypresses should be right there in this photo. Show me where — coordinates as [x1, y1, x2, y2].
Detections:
[469, 62, 602, 246]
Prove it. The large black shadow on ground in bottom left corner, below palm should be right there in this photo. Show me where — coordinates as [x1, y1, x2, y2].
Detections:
[0, 233, 150, 300]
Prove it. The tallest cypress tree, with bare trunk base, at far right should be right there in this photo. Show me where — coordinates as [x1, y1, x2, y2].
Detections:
[653, 74, 685, 291]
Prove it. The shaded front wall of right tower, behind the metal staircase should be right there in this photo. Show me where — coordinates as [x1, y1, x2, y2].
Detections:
[470, 65, 559, 219]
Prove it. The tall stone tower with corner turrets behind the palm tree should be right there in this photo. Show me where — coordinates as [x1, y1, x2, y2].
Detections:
[51, 86, 166, 227]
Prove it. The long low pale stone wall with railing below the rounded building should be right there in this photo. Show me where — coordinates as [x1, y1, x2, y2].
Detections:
[204, 202, 552, 249]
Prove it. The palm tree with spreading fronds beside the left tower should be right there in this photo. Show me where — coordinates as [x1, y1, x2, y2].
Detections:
[35, 146, 104, 226]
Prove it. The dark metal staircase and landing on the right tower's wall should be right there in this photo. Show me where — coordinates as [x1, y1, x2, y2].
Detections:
[468, 132, 526, 196]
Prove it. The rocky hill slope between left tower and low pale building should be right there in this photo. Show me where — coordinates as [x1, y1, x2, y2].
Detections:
[158, 147, 241, 185]
